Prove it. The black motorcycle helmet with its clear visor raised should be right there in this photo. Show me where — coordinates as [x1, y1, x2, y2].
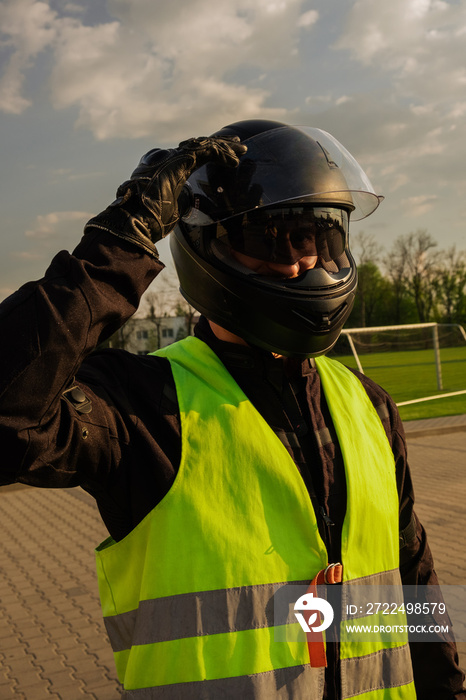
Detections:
[170, 120, 383, 358]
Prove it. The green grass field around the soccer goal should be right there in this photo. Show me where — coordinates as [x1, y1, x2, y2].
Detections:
[335, 347, 466, 420]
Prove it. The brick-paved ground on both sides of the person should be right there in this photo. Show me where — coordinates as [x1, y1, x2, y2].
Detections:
[0, 416, 466, 700]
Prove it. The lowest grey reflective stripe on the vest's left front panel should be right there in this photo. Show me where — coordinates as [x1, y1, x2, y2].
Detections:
[123, 666, 324, 700]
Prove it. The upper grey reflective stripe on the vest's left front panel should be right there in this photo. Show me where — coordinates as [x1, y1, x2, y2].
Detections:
[104, 581, 309, 652]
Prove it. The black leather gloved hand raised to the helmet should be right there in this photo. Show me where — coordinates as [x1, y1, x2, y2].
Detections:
[84, 136, 247, 258]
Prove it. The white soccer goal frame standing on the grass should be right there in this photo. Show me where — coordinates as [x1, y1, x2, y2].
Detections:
[342, 323, 466, 406]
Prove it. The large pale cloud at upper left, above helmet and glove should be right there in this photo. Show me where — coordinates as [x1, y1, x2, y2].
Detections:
[0, 0, 312, 142]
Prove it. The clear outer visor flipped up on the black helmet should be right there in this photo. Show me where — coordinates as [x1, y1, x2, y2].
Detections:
[183, 127, 383, 226]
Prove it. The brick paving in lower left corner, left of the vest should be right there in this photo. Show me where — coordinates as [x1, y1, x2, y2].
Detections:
[0, 488, 121, 700]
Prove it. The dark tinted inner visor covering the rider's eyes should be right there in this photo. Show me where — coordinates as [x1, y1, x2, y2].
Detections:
[217, 206, 348, 265]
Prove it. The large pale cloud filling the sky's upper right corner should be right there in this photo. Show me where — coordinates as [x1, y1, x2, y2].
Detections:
[322, 0, 466, 216]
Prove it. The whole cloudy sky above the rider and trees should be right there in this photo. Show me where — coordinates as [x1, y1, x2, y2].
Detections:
[0, 0, 466, 298]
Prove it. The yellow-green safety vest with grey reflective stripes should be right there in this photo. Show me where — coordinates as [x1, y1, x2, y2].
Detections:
[96, 337, 416, 700]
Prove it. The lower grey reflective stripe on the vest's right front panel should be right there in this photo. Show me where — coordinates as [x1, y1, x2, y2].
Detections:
[340, 644, 413, 700]
